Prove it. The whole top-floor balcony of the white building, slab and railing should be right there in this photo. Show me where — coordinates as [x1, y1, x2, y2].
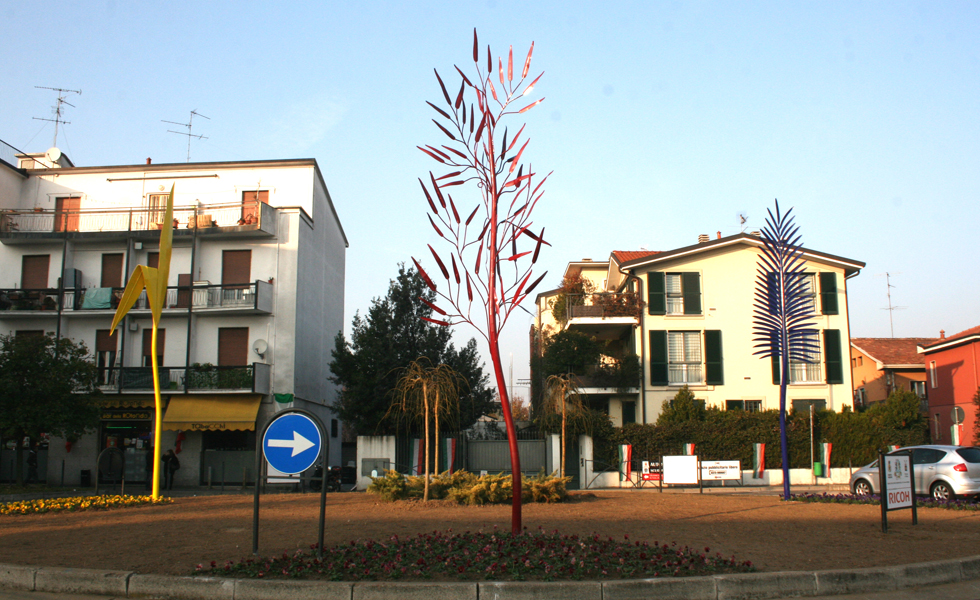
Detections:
[0, 202, 276, 244]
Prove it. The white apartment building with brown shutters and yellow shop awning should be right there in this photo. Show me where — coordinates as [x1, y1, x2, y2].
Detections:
[0, 143, 348, 489]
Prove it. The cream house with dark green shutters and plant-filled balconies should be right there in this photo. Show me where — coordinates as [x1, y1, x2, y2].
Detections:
[532, 233, 864, 426]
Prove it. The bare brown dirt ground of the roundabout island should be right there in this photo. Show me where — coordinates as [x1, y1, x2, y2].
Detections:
[0, 491, 980, 575]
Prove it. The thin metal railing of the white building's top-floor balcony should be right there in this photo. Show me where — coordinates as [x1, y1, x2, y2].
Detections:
[0, 202, 271, 238]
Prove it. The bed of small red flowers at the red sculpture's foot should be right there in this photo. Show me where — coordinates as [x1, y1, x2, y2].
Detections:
[196, 530, 755, 581]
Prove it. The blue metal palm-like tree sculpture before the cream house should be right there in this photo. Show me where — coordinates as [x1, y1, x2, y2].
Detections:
[753, 200, 819, 500]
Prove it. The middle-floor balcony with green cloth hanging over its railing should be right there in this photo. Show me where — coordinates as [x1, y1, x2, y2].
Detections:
[63, 281, 273, 316]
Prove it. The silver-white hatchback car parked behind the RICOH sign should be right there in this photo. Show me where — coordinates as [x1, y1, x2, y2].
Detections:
[850, 445, 980, 500]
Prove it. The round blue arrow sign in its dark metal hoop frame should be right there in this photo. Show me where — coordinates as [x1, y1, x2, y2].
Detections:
[252, 408, 327, 558]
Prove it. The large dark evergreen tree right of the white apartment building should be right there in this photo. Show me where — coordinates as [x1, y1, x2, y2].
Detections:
[330, 264, 493, 435]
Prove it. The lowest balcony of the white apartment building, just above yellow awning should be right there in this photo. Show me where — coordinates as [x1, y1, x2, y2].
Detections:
[99, 363, 272, 394]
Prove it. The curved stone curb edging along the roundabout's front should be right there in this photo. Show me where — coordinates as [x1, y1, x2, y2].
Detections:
[0, 556, 980, 600]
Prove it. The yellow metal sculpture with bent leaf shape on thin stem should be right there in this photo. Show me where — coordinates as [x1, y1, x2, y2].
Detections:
[109, 186, 174, 500]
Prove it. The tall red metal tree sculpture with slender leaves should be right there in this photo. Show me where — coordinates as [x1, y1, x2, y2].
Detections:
[412, 29, 550, 533]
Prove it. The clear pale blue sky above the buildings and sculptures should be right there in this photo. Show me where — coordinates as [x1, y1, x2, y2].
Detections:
[0, 0, 980, 392]
